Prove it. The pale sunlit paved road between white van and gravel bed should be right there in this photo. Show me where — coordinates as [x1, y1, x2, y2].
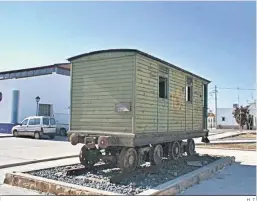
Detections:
[0, 137, 81, 168]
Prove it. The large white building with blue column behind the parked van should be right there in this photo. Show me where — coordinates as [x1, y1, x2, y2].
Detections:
[0, 63, 70, 133]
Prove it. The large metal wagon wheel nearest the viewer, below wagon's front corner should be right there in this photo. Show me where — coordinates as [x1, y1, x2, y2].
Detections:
[118, 147, 138, 172]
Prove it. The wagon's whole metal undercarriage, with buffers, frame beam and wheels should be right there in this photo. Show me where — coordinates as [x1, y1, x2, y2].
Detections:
[68, 131, 209, 172]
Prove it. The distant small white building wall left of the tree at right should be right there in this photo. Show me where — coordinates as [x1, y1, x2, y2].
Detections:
[217, 108, 238, 126]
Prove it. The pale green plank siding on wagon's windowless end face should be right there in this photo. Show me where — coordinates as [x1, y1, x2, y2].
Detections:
[70, 53, 135, 133]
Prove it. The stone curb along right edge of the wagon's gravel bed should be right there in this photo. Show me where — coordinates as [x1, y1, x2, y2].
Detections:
[138, 156, 235, 195]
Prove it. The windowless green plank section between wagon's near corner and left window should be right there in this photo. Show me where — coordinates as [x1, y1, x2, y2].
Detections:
[135, 55, 158, 133]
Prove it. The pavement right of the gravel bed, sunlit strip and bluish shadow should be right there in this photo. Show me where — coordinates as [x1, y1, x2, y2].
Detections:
[180, 148, 256, 196]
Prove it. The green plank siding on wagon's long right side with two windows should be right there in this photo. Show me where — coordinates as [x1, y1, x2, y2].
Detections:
[135, 55, 203, 134]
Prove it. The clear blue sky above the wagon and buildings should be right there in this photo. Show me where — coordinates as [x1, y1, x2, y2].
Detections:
[0, 2, 256, 108]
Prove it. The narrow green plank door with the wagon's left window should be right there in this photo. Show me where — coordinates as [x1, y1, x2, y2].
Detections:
[157, 66, 169, 133]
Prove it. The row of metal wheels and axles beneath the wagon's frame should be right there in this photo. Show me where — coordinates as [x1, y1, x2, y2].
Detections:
[79, 139, 195, 172]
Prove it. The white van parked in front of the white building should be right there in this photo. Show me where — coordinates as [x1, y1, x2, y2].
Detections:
[12, 116, 56, 139]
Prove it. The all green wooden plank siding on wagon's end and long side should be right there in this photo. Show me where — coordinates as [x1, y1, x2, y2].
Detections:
[70, 49, 204, 135]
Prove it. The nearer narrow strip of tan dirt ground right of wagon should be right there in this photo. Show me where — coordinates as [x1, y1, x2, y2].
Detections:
[196, 143, 256, 151]
